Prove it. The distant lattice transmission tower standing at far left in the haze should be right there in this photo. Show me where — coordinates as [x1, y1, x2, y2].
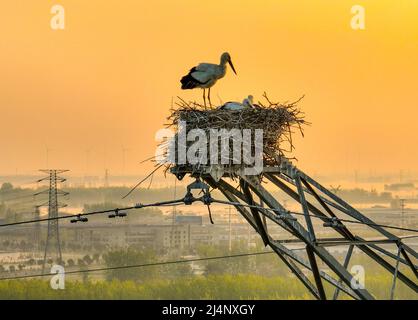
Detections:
[37, 170, 68, 272]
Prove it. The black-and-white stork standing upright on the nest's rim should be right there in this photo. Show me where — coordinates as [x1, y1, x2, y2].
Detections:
[180, 52, 237, 107]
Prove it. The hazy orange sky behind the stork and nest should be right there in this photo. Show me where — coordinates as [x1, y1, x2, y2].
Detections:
[0, 0, 418, 174]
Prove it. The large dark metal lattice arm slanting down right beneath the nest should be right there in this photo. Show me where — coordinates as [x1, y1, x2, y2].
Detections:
[171, 158, 418, 300]
